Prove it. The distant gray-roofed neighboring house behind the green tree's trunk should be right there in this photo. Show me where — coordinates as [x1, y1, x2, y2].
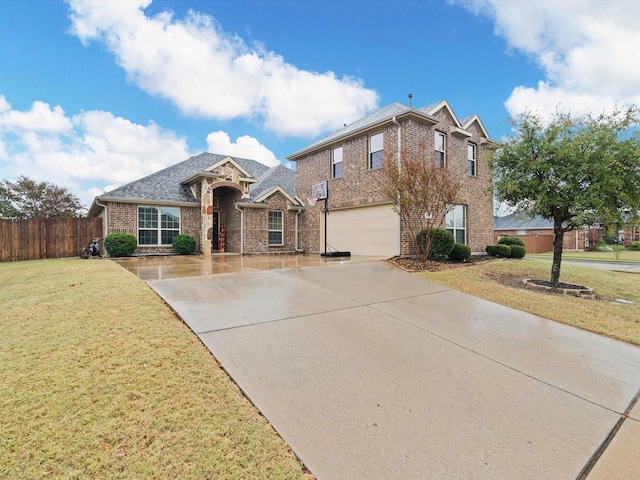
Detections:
[493, 213, 602, 253]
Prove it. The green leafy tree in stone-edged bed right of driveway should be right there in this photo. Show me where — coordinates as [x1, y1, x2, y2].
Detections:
[490, 107, 640, 283]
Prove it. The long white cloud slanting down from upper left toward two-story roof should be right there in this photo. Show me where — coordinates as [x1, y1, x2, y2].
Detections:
[69, 0, 378, 136]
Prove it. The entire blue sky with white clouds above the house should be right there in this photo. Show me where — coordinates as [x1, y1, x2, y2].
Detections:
[0, 0, 640, 206]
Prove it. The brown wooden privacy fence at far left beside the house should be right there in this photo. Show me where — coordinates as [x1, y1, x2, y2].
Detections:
[0, 218, 102, 262]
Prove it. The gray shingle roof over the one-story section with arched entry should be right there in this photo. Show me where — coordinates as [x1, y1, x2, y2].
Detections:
[99, 153, 274, 204]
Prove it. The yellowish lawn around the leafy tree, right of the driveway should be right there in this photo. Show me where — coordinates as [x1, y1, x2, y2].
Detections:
[418, 258, 640, 345]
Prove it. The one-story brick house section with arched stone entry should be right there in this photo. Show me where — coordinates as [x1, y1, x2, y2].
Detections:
[89, 153, 304, 255]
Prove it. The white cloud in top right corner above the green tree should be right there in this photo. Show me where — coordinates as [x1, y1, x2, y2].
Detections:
[457, 0, 640, 119]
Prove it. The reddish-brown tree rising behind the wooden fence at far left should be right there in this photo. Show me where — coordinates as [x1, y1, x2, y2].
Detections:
[0, 175, 84, 218]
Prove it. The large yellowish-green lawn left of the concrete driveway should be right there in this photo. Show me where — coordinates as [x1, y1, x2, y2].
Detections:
[0, 259, 308, 479]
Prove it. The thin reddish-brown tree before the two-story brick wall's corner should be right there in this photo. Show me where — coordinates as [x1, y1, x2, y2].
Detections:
[381, 145, 462, 261]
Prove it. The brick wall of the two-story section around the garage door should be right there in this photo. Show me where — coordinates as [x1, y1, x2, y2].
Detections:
[296, 108, 493, 255]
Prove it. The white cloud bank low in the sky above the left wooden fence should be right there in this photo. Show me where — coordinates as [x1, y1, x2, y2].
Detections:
[0, 96, 191, 204]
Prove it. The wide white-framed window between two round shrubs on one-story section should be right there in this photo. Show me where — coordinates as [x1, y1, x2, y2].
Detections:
[138, 206, 180, 245]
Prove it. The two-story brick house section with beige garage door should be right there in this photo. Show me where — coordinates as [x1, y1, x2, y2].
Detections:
[288, 101, 493, 257]
